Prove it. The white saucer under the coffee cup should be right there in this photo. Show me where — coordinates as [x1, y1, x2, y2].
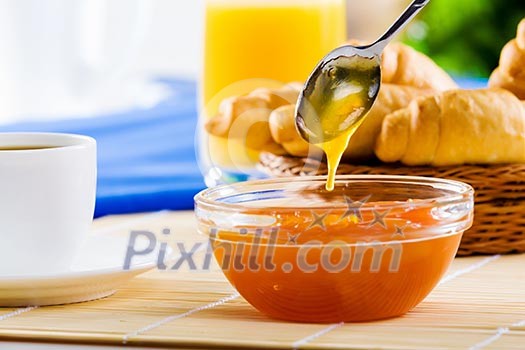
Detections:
[0, 235, 172, 307]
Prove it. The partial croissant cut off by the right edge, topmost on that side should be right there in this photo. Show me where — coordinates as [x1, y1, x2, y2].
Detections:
[489, 18, 525, 100]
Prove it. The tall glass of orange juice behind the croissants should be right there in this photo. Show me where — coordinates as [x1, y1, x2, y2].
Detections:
[198, 0, 346, 185]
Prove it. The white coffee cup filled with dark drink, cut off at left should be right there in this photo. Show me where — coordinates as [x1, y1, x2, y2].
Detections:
[0, 133, 97, 277]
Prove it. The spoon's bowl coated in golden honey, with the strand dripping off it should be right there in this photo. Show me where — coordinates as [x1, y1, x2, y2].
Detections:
[296, 56, 381, 191]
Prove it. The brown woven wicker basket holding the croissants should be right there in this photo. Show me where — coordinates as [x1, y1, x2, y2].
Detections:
[260, 153, 525, 256]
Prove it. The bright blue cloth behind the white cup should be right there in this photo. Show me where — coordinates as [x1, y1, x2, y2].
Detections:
[0, 80, 205, 217]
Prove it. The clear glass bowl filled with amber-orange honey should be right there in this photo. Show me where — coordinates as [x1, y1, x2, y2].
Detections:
[195, 175, 474, 323]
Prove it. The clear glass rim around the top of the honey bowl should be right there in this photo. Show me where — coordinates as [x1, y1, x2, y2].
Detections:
[194, 175, 474, 213]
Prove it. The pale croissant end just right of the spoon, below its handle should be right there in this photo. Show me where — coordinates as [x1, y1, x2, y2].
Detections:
[381, 43, 458, 91]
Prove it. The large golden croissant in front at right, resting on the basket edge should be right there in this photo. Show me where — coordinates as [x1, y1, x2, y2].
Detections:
[375, 89, 525, 166]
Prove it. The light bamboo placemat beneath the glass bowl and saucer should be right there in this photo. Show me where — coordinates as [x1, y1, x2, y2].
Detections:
[0, 212, 525, 349]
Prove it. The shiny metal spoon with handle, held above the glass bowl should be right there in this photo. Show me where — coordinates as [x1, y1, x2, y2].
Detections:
[295, 0, 430, 144]
